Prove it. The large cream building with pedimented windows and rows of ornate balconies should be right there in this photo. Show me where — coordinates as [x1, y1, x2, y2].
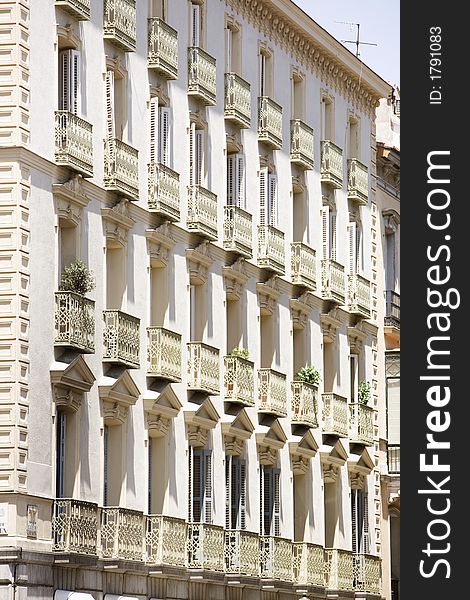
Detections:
[0, 0, 390, 600]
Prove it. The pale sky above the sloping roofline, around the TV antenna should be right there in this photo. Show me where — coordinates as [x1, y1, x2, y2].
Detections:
[294, 0, 400, 84]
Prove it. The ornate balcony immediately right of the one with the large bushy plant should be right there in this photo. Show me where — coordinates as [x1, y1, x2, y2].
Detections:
[103, 310, 140, 369]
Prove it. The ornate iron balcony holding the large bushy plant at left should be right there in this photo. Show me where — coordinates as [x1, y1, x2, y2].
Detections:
[54, 292, 95, 353]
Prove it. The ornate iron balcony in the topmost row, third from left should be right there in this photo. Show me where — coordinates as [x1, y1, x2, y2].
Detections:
[147, 19, 178, 79]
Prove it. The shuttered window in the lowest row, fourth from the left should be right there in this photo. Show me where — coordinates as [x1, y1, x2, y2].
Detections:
[189, 446, 212, 524]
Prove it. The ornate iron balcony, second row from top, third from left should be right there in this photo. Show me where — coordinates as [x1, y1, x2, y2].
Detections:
[148, 163, 180, 221]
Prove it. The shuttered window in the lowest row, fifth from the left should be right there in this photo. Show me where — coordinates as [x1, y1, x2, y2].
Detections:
[225, 456, 246, 529]
